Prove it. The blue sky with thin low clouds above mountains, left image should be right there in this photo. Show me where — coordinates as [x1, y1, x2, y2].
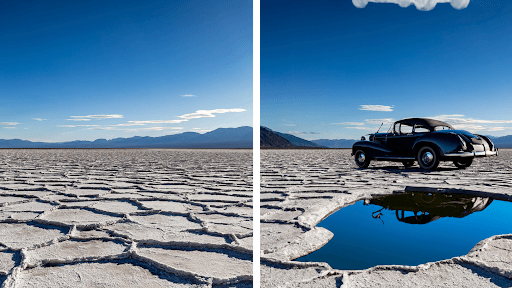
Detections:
[0, 0, 254, 142]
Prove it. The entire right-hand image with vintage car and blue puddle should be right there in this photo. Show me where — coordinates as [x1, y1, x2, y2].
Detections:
[260, 0, 512, 287]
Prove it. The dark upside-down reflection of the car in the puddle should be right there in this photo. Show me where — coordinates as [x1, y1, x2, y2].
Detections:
[364, 192, 493, 224]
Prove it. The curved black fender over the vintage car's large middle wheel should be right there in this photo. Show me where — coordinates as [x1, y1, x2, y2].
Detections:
[412, 132, 462, 157]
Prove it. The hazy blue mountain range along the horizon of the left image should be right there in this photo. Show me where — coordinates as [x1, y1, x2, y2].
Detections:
[0, 126, 254, 148]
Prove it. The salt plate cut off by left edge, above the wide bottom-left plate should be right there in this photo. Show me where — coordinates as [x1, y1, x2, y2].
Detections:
[0, 221, 70, 250]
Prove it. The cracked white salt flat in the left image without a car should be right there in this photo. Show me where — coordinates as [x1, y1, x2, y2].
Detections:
[0, 149, 254, 288]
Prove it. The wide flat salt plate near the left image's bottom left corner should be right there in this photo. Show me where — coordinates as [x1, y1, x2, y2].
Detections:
[21, 238, 132, 268]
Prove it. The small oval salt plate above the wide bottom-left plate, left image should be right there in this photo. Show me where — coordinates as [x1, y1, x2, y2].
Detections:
[36, 207, 126, 229]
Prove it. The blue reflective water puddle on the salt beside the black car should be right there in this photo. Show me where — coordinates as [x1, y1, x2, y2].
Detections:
[296, 192, 512, 270]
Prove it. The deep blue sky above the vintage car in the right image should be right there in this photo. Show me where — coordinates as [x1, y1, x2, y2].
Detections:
[260, 0, 512, 140]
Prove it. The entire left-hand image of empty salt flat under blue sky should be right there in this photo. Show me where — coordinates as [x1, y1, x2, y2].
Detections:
[0, 0, 254, 288]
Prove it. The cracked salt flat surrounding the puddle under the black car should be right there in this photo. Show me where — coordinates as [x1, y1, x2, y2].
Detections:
[260, 149, 512, 287]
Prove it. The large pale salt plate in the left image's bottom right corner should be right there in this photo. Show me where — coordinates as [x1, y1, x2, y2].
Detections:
[133, 245, 254, 285]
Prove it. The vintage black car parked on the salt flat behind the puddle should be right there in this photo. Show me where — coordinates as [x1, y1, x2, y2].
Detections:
[352, 118, 498, 170]
